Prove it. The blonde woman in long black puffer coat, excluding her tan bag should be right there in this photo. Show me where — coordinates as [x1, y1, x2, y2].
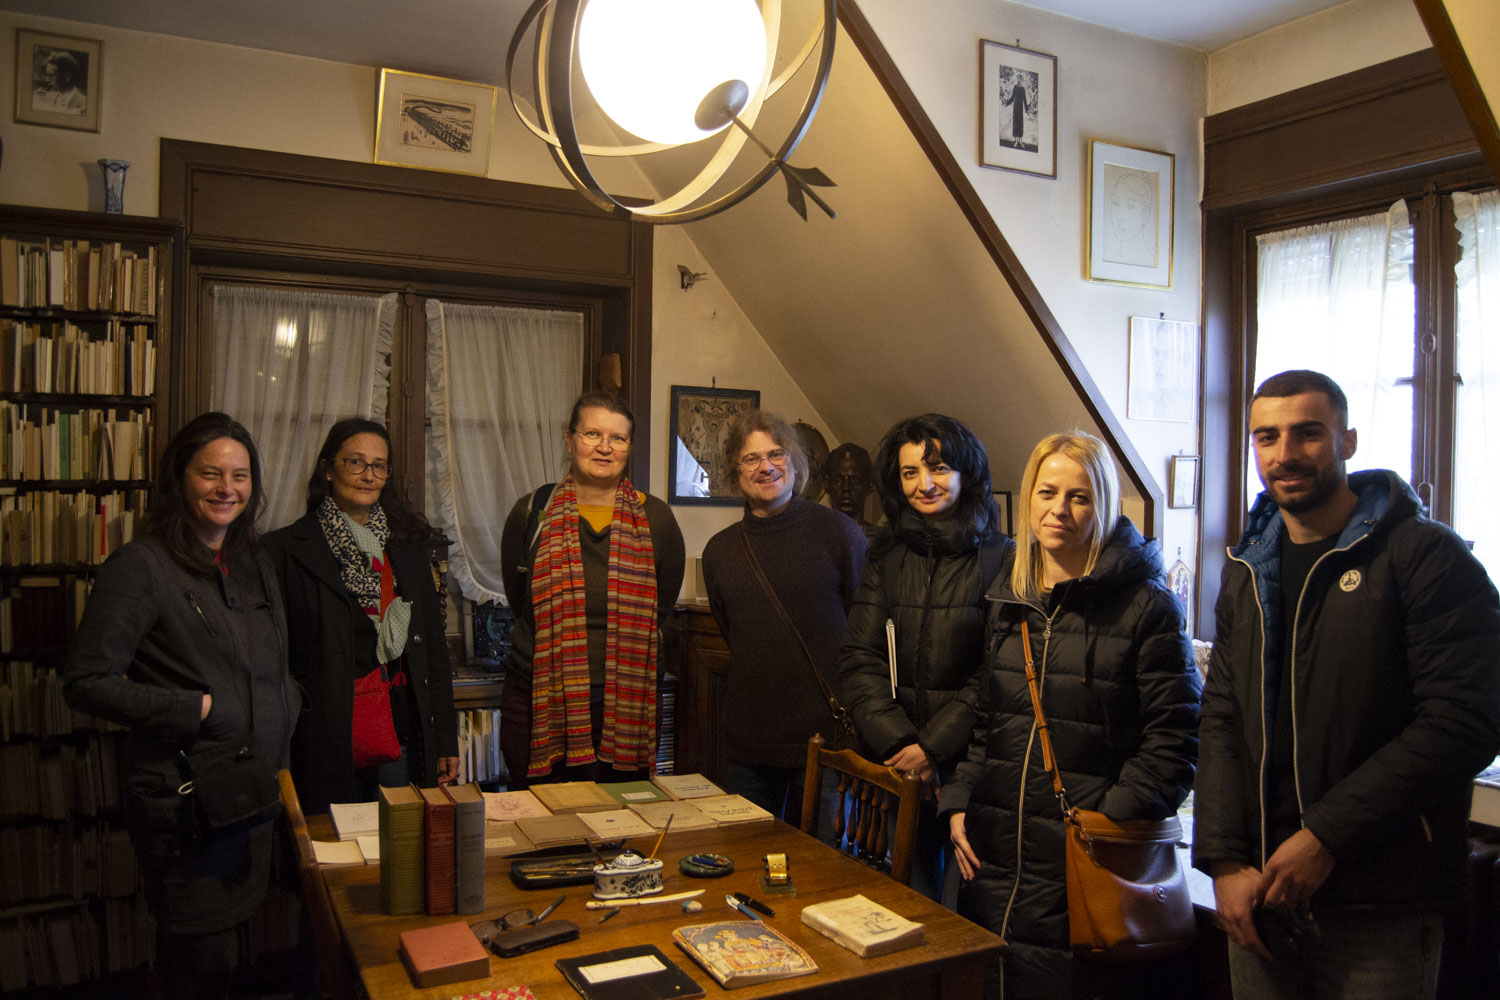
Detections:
[942, 433, 1202, 999]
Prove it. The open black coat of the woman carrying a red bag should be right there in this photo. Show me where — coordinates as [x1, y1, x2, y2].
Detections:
[266, 514, 458, 813]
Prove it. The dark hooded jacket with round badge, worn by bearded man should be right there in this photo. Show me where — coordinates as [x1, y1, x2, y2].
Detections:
[1193, 471, 1500, 910]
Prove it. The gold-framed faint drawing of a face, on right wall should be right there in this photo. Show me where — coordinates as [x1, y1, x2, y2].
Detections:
[1088, 139, 1176, 288]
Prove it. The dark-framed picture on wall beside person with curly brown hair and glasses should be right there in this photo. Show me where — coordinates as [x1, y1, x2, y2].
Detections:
[666, 385, 761, 507]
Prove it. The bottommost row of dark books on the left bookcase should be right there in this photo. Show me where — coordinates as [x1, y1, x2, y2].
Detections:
[0, 894, 156, 993]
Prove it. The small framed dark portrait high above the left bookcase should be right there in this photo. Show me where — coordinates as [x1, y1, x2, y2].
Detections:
[15, 28, 104, 132]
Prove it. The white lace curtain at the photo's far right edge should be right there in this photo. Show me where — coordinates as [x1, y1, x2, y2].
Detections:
[1454, 190, 1500, 580]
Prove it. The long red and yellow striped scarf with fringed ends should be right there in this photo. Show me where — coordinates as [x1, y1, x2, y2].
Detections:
[527, 475, 657, 778]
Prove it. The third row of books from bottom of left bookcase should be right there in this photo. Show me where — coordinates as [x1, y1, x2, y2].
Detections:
[0, 730, 120, 821]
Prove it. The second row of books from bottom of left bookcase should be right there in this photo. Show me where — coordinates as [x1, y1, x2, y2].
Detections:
[0, 823, 141, 907]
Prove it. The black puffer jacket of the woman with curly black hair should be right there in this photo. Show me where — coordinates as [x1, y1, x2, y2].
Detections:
[839, 510, 1016, 778]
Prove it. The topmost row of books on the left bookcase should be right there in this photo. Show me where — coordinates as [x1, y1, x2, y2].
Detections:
[0, 237, 158, 316]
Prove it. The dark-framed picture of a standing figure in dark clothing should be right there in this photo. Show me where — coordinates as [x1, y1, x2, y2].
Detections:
[980, 39, 1058, 177]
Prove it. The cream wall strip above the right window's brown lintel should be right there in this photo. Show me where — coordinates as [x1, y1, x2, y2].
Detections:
[1208, 0, 1428, 114]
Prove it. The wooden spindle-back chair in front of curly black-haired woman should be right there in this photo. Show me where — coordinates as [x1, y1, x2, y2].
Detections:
[803, 733, 923, 885]
